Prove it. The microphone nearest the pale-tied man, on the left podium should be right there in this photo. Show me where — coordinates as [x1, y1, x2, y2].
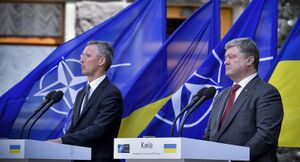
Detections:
[27, 91, 64, 139]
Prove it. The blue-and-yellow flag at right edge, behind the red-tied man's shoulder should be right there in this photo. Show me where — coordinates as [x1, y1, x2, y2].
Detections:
[269, 17, 300, 147]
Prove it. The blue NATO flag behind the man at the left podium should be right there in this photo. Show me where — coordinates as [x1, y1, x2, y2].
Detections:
[0, 0, 166, 140]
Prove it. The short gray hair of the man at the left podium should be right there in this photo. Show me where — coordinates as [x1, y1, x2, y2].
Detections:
[87, 40, 114, 71]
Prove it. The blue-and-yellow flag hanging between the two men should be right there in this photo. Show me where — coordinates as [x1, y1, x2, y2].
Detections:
[119, 0, 220, 137]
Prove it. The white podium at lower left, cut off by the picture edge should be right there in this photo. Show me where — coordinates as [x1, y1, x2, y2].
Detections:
[0, 139, 91, 162]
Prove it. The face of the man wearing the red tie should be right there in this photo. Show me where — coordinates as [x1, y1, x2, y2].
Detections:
[224, 47, 249, 81]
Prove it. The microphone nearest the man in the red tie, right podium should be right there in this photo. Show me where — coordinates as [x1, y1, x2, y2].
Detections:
[179, 87, 217, 137]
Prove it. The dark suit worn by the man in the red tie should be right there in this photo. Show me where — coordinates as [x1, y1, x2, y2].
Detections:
[204, 76, 283, 162]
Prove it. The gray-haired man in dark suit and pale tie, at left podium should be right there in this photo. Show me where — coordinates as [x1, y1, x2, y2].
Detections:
[50, 41, 123, 162]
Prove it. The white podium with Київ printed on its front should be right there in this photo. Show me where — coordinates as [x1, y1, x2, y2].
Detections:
[114, 138, 250, 162]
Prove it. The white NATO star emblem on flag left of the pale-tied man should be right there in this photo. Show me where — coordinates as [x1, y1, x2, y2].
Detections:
[10, 58, 87, 139]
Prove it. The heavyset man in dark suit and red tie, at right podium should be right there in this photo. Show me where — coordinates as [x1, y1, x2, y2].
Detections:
[204, 38, 283, 162]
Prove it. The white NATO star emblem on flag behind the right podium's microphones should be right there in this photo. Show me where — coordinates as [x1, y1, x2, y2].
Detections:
[155, 50, 224, 131]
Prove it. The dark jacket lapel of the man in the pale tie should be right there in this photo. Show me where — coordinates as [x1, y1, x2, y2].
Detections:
[77, 77, 109, 121]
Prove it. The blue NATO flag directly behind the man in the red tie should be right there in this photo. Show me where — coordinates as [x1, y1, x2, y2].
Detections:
[140, 0, 277, 139]
